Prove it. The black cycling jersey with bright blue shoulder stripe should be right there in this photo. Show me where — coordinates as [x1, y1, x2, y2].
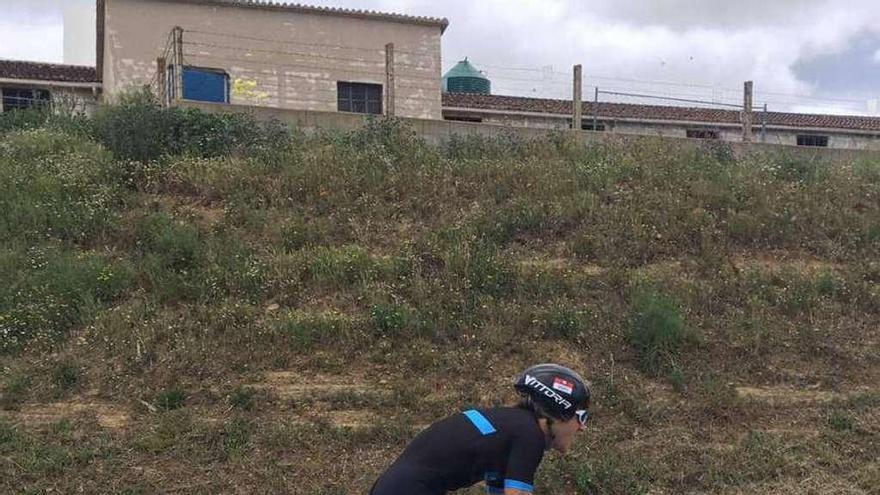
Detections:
[370, 407, 545, 495]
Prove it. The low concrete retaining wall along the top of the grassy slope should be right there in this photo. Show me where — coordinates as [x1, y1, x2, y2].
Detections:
[179, 101, 880, 162]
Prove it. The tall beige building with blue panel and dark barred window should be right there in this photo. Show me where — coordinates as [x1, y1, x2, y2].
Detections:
[97, 0, 448, 119]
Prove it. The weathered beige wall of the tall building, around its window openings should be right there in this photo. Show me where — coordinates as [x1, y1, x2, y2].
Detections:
[103, 0, 441, 119]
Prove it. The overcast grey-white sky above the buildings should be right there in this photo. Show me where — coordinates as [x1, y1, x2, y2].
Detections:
[0, 0, 880, 114]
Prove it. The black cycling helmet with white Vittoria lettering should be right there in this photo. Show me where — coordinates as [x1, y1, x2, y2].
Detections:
[513, 363, 590, 421]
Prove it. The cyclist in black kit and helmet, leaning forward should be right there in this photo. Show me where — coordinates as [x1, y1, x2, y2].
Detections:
[370, 364, 590, 495]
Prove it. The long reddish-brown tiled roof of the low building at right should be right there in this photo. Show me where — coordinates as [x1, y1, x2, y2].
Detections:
[443, 93, 880, 131]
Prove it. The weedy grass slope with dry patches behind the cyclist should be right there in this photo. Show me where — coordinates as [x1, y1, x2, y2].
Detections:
[0, 115, 880, 494]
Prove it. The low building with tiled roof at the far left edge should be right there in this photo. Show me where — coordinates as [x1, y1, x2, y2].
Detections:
[0, 60, 101, 113]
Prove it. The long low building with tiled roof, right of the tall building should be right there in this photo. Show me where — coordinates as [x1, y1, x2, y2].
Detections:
[443, 93, 880, 150]
